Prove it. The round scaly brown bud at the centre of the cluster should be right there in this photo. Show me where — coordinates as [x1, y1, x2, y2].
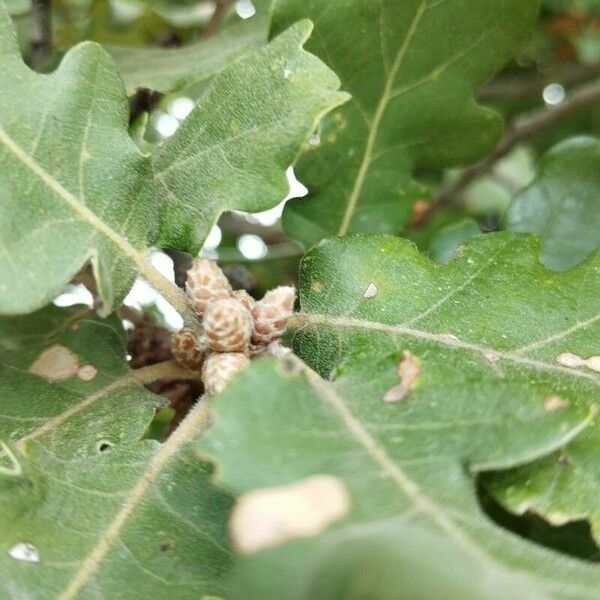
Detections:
[202, 298, 252, 352]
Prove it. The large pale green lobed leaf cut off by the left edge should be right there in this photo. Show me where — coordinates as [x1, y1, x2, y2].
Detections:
[0, 4, 158, 314]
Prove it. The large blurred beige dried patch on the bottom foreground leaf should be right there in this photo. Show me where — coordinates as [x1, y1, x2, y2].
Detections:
[230, 475, 350, 554]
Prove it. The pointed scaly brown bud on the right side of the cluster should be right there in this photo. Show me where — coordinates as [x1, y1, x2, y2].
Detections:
[252, 287, 296, 345]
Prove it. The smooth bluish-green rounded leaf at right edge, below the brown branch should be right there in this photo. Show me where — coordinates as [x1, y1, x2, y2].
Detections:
[506, 137, 600, 271]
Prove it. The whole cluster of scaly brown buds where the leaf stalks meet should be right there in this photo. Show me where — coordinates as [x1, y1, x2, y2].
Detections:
[171, 257, 296, 395]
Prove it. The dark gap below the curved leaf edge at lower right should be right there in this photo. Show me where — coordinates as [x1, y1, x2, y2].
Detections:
[477, 478, 600, 563]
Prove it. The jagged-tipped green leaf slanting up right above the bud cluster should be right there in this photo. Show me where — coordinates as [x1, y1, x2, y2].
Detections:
[153, 21, 348, 251]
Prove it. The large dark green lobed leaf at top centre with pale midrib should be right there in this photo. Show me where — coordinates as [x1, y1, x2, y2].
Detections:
[273, 0, 538, 246]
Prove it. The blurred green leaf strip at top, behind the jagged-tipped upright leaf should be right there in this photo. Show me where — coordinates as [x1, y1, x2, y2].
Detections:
[107, 17, 267, 92]
